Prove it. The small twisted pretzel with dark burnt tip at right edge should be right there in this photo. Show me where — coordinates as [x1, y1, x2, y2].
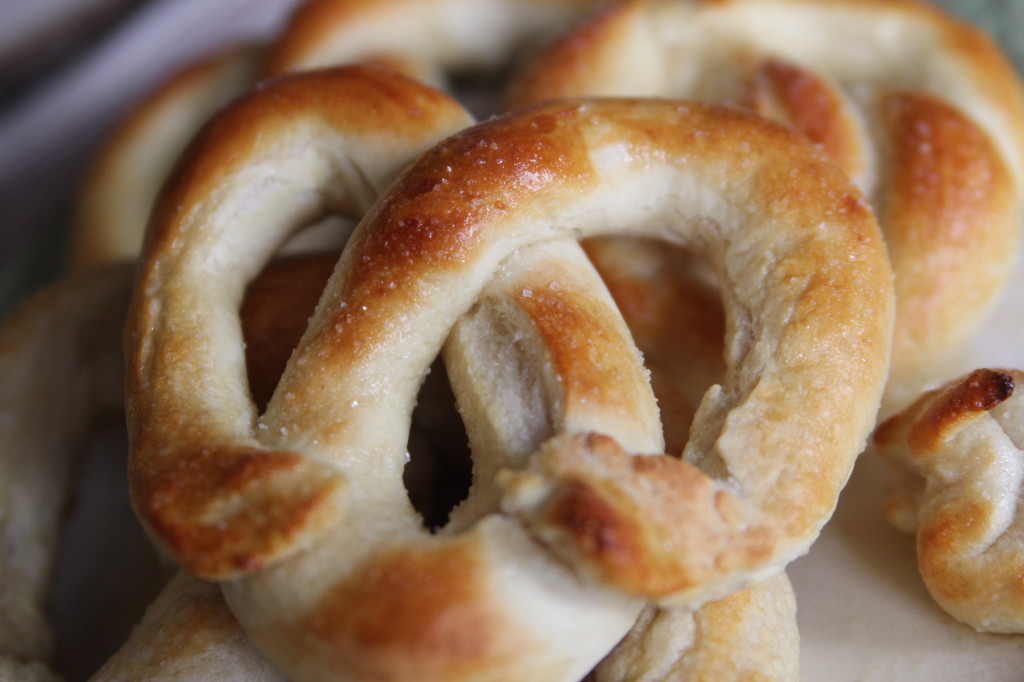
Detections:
[873, 369, 1024, 633]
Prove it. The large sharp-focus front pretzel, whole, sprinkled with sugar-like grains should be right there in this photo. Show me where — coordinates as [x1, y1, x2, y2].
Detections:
[128, 69, 892, 680]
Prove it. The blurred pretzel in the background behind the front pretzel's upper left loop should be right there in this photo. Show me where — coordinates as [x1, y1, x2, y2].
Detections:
[71, 0, 594, 267]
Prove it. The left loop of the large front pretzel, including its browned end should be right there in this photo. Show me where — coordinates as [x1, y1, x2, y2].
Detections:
[128, 63, 469, 577]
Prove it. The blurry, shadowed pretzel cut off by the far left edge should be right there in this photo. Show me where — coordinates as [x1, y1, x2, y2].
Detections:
[0, 261, 131, 680]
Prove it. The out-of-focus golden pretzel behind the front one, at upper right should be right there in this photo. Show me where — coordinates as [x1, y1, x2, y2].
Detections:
[512, 0, 1024, 413]
